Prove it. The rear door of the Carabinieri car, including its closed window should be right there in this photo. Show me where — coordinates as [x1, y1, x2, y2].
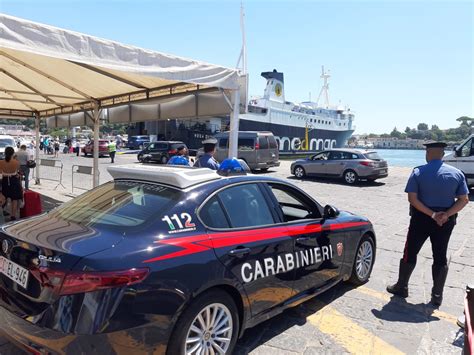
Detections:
[198, 183, 294, 315]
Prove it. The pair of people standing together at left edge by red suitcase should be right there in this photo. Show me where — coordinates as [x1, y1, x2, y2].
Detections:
[0, 145, 32, 221]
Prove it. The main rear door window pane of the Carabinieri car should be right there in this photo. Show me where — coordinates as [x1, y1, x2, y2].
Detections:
[218, 184, 275, 228]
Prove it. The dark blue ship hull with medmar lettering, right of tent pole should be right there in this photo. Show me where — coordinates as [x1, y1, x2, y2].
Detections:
[239, 118, 354, 153]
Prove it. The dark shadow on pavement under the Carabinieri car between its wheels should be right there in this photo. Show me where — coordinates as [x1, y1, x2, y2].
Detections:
[234, 283, 354, 355]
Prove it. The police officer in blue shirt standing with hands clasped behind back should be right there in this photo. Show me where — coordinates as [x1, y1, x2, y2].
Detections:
[387, 142, 469, 306]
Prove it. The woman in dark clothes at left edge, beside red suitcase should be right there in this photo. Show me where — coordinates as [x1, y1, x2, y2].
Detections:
[0, 147, 23, 221]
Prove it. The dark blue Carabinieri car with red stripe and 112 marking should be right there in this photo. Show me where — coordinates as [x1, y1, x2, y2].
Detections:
[0, 165, 376, 355]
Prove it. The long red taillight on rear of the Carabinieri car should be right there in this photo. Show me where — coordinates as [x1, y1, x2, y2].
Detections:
[31, 268, 150, 296]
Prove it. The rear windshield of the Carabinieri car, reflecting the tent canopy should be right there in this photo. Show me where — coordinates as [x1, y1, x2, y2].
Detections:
[51, 181, 183, 232]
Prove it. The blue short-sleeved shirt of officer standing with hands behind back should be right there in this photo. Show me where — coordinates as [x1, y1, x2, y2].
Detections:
[405, 159, 469, 209]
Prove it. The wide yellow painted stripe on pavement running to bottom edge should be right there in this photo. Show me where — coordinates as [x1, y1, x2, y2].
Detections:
[307, 301, 404, 355]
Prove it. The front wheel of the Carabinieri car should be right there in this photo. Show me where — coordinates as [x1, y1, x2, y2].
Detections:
[349, 234, 375, 285]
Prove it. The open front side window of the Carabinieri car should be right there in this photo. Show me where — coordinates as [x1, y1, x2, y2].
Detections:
[268, 183, 321, 222]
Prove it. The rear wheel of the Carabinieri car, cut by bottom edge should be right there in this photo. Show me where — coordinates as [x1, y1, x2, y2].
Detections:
[167, 290, 239, 355]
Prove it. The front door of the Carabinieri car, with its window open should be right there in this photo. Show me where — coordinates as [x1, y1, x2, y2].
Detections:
[266, 182, 344, 293]
